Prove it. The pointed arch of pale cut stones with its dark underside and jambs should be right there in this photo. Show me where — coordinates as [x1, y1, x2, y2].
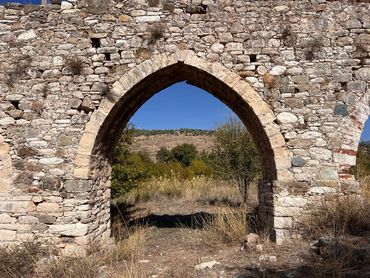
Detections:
[74, 51, 293, 245]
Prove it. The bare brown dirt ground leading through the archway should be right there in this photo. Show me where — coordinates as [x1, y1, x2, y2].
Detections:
[110, 201, 362, 278]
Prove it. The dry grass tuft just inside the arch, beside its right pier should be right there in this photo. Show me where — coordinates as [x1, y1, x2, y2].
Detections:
[199, 207, 249, 244]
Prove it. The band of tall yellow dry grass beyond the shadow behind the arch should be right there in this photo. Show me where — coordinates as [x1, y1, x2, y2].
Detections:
[116, 177, 246, 206]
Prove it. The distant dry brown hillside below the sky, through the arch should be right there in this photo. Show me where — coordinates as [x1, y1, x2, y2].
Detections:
[131, 128, 214, 161]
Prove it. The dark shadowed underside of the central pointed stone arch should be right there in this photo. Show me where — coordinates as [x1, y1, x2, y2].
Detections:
[94, 63, 277, 181]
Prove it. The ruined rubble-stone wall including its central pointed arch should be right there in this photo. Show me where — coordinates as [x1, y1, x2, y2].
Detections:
[0, 0, 370, 254]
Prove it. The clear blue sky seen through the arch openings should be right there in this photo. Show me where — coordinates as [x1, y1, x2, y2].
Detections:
[130, 82, 370, 140]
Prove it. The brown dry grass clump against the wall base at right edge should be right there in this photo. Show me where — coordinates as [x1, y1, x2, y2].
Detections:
[301, 196, 370, 238]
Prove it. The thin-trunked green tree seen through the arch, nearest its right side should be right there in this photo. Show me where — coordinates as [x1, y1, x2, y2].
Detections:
[211, 119, 261, 201]
